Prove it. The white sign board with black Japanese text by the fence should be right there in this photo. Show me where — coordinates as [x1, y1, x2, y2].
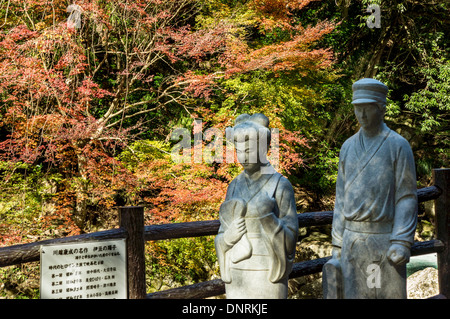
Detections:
[40, 239, 127, 299]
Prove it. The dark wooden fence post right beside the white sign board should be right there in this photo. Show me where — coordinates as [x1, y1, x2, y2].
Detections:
[119, 206, 146, 299]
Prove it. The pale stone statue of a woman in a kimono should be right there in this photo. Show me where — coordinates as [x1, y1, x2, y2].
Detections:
[215, 113, 298, 299]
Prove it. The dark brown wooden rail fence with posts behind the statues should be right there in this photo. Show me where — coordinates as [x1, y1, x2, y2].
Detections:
[0, 169, 450, 299]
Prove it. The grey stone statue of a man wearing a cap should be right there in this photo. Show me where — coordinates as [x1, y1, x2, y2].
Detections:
[323, 78, 417, 299]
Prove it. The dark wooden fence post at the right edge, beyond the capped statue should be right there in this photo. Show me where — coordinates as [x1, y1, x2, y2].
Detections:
[433, 168, 450, 298]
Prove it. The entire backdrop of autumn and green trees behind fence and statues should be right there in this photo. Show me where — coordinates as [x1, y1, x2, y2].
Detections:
[0, 0, 450, 298]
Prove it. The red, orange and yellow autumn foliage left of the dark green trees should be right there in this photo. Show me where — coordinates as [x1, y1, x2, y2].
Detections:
[0, 0, 334, 296]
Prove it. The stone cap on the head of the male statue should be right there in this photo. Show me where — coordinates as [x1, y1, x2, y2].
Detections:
[352, 78, 388, 105]
